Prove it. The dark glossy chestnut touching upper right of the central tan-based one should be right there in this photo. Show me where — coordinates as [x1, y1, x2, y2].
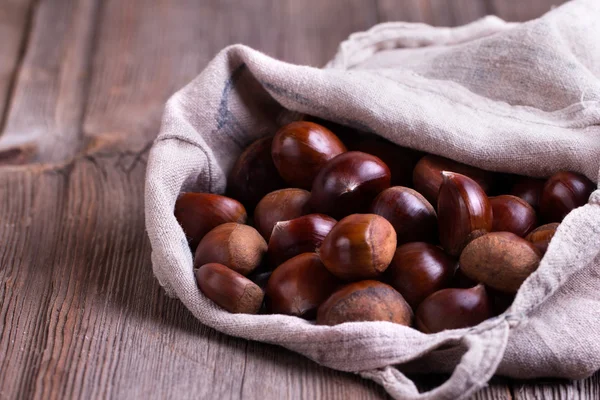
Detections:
[370, 186, 438, 245]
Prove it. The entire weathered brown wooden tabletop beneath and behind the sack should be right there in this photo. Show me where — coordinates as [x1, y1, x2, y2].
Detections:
[0, 0, 600, 399]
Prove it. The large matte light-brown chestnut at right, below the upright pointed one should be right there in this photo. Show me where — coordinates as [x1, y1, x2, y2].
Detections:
[459, 232, 540, 293]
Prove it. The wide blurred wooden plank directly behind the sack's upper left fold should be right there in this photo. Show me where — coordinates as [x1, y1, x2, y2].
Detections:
[84, 0, 377, 156]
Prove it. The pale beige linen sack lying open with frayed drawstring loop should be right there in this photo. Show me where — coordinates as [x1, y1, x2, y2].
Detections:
[146, 0, 600, 399]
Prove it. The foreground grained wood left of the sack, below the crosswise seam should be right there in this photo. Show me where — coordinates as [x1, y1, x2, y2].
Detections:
[0, 153, 385, 399]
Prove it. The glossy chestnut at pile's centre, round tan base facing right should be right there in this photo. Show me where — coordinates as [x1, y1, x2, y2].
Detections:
[317, 214, 396, 281]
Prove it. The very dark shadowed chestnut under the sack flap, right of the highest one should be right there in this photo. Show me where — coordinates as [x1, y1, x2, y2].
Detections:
[347, 135, 423, 187]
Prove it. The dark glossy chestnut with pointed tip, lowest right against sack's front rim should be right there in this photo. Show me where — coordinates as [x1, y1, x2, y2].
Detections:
[415, 285, 493, 333]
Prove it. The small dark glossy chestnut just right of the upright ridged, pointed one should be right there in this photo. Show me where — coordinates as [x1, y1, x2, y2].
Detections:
[489, 194, 537, 237]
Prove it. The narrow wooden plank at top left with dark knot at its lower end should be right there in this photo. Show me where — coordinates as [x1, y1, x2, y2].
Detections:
[0, 0, 100, 164]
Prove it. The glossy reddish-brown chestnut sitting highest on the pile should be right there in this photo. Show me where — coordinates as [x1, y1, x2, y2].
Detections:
[271, 121, 346, 189]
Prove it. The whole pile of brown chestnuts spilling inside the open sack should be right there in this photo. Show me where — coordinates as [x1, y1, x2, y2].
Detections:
[175, 118, 595, 333]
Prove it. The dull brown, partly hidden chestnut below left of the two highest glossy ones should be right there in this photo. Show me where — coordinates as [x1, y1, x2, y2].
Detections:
[254, 188, 310, 240]
